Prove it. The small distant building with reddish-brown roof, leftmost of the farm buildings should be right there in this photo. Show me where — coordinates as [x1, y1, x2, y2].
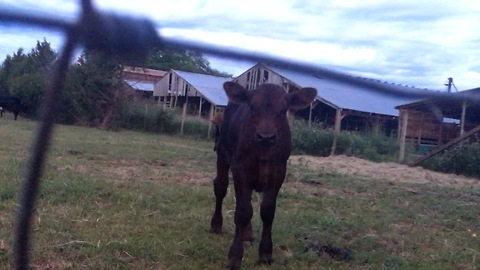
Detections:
[122, 66, 167, 98]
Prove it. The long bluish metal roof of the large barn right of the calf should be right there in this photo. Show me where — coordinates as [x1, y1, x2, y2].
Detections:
[265, 66, 428, 116]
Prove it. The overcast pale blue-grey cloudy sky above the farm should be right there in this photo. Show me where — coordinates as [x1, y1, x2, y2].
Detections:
[0, 0, 480, 90]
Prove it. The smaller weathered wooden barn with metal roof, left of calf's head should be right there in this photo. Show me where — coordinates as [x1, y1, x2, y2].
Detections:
[153, 69, 231, 119]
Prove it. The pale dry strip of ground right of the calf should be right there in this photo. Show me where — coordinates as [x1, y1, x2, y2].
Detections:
[289, 155, 480, 187]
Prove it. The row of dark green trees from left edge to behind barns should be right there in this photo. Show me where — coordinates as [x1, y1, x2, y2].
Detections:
[0, 39, 232, 128]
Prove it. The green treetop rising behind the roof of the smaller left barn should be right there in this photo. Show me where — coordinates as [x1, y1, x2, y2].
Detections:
[146, 49, 232, 77]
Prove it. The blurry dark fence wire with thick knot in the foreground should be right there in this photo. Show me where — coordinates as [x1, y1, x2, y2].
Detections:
[0, 0, 472, 269]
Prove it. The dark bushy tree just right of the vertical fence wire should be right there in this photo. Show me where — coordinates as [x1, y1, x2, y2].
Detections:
[60, 50, 130, 129]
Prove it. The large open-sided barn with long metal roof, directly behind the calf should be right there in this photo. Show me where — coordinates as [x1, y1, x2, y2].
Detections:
[235, 63, 427, 135]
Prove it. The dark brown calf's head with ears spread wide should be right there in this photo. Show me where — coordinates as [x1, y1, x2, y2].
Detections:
[223, 82, 317, 146]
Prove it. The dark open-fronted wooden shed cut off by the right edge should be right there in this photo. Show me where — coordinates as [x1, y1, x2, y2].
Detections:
[396, 88, 480, 160]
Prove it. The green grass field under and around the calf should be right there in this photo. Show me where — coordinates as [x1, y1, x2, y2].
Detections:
[0, 121, 480, 269]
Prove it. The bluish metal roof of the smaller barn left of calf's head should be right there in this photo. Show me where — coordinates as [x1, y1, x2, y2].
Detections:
[173, 70, 232, 106]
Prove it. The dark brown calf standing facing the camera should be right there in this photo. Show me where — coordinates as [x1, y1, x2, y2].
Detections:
[210, 82, 317, 269]
